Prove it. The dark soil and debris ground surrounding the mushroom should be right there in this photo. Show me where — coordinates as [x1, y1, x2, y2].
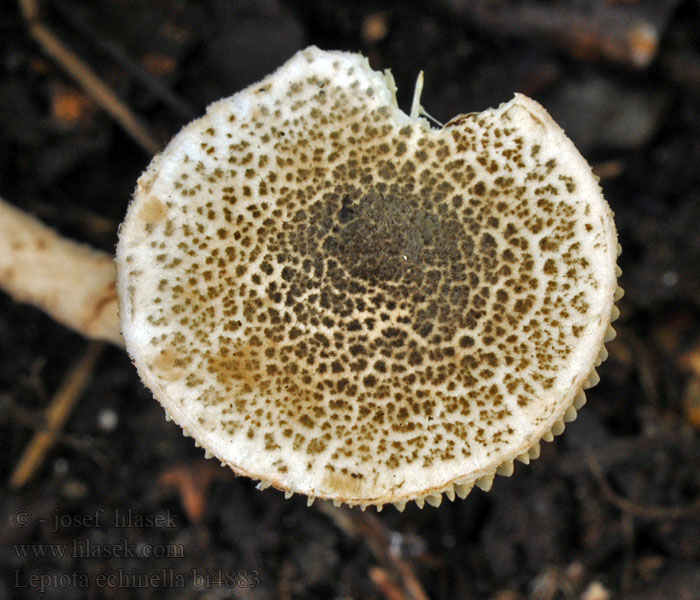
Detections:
[0, 0, 700, 600]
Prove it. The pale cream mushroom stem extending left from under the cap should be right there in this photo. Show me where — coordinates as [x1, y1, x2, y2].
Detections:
[0, 198, 124, 346]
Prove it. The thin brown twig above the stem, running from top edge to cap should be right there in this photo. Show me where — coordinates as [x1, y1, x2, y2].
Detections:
[19, 0, 161, 154]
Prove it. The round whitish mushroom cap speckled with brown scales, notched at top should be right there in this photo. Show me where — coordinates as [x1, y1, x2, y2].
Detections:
[117, 47, 617, 507]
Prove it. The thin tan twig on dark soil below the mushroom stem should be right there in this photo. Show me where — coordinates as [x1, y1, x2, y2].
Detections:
[9, 342, 105, 489]
